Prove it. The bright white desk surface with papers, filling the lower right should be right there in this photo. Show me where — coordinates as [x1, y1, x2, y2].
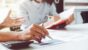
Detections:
[0, 24, 88, 50]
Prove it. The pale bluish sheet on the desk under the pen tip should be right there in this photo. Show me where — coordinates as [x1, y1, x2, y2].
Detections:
[30, 39, 64, 49]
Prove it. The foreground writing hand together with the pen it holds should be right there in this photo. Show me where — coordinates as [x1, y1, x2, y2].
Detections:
[27, 24, 52, 43]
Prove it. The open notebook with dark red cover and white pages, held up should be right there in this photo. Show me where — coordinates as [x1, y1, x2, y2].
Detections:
[46, 7, 75, 29]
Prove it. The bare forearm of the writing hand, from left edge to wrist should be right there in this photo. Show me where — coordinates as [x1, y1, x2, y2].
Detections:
[0, 32, 26, 42]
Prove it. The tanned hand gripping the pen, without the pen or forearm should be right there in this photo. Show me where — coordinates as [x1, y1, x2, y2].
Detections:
[19, 24, 48, 43]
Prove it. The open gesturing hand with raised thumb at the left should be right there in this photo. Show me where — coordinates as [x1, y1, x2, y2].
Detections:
[2, 10, 24, 27]
